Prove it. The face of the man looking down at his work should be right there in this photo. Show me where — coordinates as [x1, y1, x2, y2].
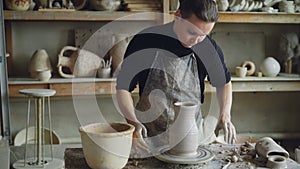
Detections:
[174, 14, 215, 48]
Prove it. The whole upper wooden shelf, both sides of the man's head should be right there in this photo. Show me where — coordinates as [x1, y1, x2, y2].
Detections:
[4, 10, 300, 24]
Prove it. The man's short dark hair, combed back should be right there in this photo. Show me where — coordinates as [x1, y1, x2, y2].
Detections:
[179, 0, 219, 22]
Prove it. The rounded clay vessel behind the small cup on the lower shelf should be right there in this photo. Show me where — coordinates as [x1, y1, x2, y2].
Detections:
[29, 49, 52, 78]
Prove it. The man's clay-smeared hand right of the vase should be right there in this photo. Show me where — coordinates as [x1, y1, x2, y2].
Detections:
[215, 113, 236, 144]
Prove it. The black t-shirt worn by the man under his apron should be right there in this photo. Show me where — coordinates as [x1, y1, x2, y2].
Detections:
[117, 22, 231, 103]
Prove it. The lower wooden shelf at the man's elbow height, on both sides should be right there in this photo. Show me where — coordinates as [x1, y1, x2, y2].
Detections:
[8, 77, 300, 97]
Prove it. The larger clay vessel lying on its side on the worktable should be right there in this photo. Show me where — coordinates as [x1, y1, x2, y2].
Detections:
[255, 137, 289, 158]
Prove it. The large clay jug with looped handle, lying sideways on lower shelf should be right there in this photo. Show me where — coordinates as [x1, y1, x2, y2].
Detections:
[57, 46, 103, 78]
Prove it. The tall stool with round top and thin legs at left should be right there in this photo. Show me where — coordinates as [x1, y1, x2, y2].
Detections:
[13, 89, 64, 169]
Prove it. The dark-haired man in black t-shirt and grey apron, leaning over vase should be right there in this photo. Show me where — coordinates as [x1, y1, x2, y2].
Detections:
[117, 0, 236, 156]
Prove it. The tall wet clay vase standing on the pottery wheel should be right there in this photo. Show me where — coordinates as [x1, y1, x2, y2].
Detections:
[169, 102, 199, 156]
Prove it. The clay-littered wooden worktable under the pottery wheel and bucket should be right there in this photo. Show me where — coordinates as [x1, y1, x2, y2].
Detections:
[64, 144, 300, 169]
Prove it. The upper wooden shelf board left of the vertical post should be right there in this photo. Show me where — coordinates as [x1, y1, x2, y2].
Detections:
[4, 10, 161, 22]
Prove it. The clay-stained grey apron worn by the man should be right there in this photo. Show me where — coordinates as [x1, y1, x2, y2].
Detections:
[136, 51, 202, 147]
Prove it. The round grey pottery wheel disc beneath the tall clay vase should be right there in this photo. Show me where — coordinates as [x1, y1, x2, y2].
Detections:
[155, 147, 215, 164]
